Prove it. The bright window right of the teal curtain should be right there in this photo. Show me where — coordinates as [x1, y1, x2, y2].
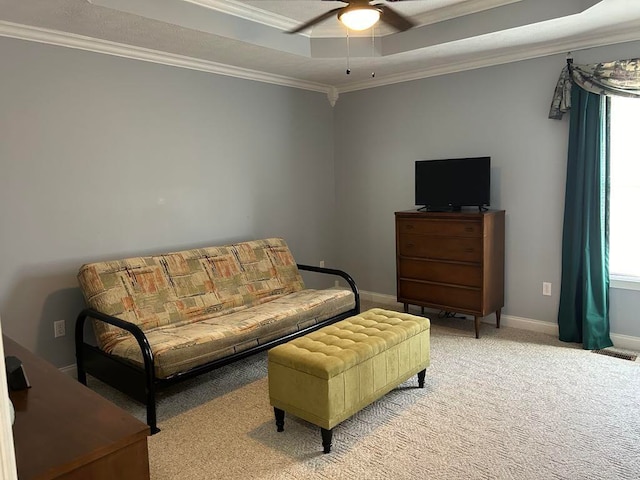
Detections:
[609, 97, 640, 290]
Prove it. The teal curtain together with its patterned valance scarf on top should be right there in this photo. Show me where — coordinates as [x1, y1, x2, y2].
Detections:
[549, 58, 640, 350]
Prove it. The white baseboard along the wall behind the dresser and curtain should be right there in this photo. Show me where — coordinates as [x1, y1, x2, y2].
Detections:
[360, 291, 640, 351]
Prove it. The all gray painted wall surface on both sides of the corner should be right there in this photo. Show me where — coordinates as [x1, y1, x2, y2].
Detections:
[0, 34, 640, 366]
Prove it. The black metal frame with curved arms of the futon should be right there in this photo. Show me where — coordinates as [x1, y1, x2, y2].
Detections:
[75, 264, 360, 434]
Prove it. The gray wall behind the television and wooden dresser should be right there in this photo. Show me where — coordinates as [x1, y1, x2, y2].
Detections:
[334, 43, 640, 337]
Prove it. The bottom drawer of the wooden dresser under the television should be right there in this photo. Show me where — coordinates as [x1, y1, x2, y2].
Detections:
[398, 279, 482, 312]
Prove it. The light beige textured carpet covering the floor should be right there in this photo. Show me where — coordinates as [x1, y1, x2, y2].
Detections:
[89, 310, 640, 480]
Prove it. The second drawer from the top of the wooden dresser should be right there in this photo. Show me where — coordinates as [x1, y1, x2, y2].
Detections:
[398, 234, 482, 263]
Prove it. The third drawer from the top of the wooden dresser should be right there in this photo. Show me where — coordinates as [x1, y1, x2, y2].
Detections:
[398, 257, 482, 287]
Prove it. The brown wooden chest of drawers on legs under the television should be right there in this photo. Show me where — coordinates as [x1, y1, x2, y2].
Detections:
[395, 210, 505, 338]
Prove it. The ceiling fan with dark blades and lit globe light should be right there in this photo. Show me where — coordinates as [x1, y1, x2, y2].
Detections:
[287, 0, 416, 33]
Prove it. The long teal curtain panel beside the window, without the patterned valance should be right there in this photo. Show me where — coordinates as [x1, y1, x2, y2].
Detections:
[558, 84, 613, 350]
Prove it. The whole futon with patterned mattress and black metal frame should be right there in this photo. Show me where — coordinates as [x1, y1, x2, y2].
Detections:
[75, 238, 360, 433]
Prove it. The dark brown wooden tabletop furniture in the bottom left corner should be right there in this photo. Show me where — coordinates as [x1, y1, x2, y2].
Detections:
[3, 335, 149, 480]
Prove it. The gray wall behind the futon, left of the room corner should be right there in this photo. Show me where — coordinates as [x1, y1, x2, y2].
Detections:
[0, 38, 335, 366]
